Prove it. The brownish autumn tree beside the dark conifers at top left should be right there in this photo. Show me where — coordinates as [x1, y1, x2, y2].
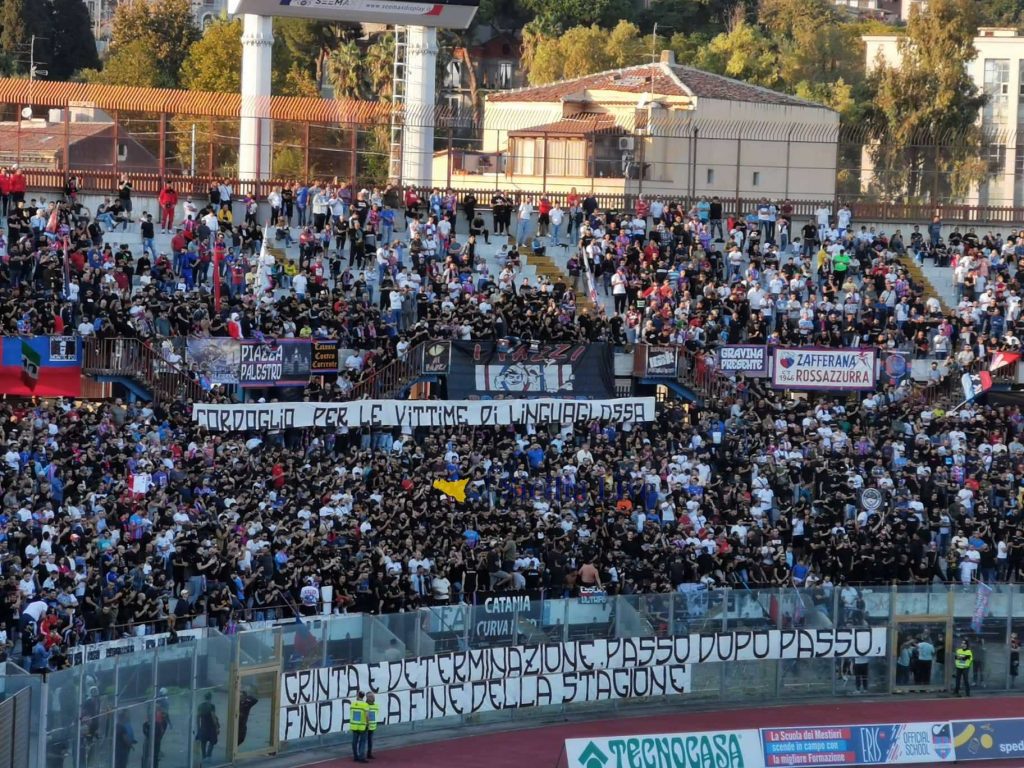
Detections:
[105, 0, 201, 86]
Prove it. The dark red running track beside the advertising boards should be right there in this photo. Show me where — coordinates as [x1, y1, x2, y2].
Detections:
[305, 696, 1024, 768]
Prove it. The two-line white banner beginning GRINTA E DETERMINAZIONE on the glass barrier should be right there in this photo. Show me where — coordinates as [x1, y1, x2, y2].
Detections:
[279, 628, 886, 741]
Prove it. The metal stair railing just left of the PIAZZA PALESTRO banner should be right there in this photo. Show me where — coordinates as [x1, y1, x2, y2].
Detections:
[82, 337, 202, 402]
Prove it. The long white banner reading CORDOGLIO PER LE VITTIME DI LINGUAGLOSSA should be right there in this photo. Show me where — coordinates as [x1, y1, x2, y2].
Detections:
[193, 397, 654, 432]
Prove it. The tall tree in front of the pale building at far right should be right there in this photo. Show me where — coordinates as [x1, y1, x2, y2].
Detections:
[867, 0, 988, 201]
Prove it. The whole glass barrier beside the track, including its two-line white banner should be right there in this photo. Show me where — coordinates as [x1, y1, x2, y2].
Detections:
[14, 584, 1024, 768]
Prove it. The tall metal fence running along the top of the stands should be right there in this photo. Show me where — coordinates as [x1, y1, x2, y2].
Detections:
[6, 79, 1024, 214]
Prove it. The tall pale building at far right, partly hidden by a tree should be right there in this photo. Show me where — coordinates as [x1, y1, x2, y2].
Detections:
[863, 27, 1024, 206]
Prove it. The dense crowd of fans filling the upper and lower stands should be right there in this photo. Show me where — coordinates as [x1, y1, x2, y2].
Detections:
[0, 171, 1024, 672]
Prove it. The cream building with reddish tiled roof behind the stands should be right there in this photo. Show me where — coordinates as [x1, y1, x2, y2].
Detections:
[434, 51, 839, 207]
